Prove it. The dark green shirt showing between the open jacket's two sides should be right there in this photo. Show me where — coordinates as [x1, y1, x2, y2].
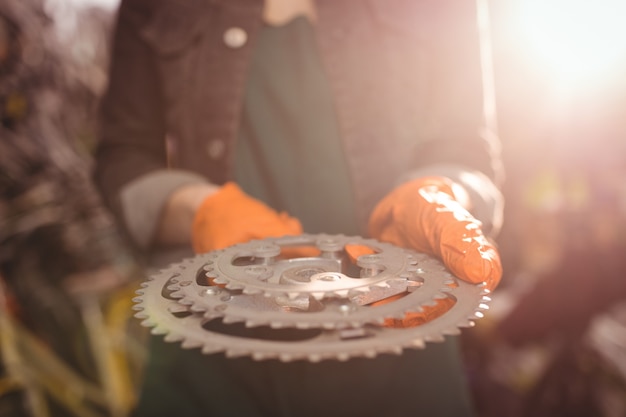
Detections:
[234, 18, 358, 235]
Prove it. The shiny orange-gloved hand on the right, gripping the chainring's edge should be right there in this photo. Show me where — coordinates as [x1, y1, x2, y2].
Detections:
[369, 177, 502, 290]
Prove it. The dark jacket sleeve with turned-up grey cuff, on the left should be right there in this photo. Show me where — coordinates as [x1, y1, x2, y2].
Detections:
[94, 0, 204, 248]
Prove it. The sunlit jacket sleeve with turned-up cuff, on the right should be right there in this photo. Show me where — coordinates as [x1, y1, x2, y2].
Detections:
[407, 0, 504, 235]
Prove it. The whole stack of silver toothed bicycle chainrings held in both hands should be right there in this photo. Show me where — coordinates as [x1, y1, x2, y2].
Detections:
[134, 235, 489, 362]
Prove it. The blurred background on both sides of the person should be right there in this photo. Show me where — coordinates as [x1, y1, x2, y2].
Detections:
[0, 0, 626, 417]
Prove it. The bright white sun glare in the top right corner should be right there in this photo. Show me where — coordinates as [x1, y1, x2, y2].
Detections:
[515, 0, 626, 90]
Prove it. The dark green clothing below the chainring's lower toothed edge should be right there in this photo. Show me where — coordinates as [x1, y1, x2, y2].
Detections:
[135, 336, 472, 417]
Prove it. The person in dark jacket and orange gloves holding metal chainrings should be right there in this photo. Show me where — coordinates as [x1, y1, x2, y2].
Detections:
[94, 0, 502, 417]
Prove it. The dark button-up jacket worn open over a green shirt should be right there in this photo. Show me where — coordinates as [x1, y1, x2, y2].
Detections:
[96, 0, 498, 234]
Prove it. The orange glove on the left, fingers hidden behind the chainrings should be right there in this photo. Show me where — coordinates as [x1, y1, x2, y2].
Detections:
[191, 182, 302, 253]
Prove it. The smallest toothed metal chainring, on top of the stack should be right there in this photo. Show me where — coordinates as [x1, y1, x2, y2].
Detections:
[196, 234, 428, 300]
